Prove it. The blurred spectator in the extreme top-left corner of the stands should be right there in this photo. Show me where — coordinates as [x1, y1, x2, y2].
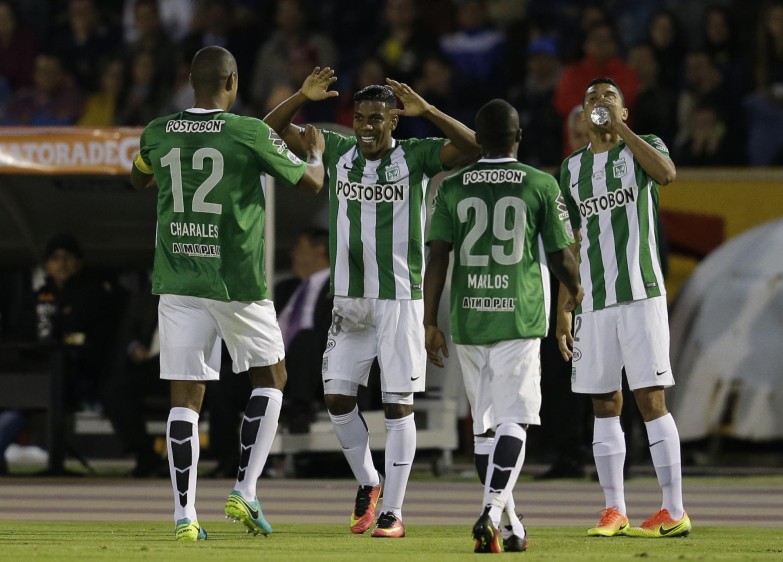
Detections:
[0, 0, 38, 90]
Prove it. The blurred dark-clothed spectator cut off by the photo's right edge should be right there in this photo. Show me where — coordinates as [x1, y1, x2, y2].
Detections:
[744, 0, 783, 166]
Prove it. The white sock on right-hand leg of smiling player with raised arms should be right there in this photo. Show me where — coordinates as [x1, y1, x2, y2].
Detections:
[383, 414, 416, 519]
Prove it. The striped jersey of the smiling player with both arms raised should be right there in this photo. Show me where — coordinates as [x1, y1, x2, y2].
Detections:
[323, 131, 446, 300]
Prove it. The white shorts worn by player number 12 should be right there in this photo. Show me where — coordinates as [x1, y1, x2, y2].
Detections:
[158, 295, 285, 381]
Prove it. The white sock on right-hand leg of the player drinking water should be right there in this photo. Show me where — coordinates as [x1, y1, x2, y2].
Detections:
[644, 414, 685, 519]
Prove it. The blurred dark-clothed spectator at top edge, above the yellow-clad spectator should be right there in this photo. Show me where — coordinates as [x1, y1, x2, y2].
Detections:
[49, 0, 121, 92]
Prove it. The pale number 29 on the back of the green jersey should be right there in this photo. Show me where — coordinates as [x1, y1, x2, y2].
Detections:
[457, 197, 527, 266]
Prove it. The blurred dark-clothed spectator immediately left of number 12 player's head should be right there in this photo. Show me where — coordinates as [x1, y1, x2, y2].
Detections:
[117, 51, 168, 126]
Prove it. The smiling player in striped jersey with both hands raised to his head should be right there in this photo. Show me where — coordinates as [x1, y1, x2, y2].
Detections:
[265, 68, 479, 538]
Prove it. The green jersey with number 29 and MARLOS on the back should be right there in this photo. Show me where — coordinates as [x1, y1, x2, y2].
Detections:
[427, 158, 573, 345]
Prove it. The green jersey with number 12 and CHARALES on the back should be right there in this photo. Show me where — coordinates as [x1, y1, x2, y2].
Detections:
[134, 109, 307, 301]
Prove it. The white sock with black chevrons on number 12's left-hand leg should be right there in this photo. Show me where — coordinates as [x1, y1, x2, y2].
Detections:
[166, 408, 201, 523]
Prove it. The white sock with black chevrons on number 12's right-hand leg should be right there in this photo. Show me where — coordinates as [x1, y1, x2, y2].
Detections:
[234, 388, 283, 501]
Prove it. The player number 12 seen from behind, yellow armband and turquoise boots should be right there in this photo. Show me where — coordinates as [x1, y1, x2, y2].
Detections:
[131, 46, 324, 541]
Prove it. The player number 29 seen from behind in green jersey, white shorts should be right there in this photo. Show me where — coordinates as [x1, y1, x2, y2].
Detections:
[424, 99, 582, 552]
